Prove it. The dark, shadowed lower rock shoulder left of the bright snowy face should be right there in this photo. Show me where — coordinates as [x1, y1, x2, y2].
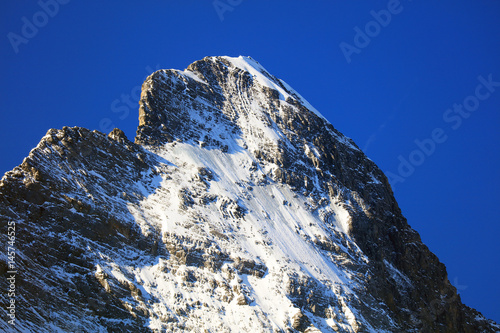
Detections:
[0, 127, 161, 332]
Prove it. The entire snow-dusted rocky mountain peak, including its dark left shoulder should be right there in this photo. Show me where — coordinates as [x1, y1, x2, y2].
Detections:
[0, 57, 500, 332]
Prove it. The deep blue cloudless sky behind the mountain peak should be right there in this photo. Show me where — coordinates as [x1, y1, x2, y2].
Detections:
[0, 0, 500, 322]
